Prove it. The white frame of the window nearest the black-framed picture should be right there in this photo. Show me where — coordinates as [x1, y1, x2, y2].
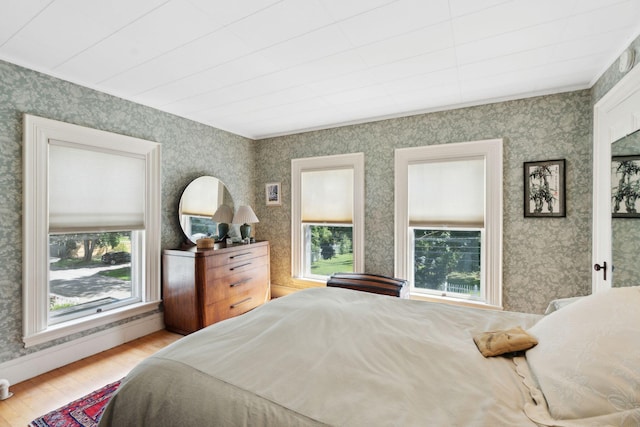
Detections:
[394, 139, 503, 308]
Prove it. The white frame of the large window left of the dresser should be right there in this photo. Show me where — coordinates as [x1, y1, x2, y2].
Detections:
[22, 114, 161, 347]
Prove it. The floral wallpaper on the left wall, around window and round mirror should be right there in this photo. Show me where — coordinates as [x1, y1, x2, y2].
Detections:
[0, 61, 255, 362]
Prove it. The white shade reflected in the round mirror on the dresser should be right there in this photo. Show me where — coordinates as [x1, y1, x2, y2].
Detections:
[180, 176, 223, 216]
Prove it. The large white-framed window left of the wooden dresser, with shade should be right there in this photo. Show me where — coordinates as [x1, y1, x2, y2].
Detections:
[23, 115, 160, 347]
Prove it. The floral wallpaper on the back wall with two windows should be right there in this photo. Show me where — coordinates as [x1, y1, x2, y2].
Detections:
[256, 90, 592, 313]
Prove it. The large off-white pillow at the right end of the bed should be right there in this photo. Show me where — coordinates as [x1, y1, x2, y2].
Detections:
[526, 287, 640, 420]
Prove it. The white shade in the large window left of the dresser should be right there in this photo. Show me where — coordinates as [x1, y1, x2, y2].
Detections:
[49, 140, 146, 233]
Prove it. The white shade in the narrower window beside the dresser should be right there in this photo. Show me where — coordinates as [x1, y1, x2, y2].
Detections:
[301, 169, 353, 224]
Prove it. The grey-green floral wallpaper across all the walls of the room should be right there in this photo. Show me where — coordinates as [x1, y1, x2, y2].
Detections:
[0, 31, 640, 363]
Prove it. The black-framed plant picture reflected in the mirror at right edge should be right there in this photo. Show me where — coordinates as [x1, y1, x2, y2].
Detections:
[611, 155, 640, 218]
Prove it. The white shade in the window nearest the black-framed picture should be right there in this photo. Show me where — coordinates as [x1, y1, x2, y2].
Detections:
[408, 158, 485, 227]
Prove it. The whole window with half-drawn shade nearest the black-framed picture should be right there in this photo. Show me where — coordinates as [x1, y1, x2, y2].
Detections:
[395, 140, 502, 306]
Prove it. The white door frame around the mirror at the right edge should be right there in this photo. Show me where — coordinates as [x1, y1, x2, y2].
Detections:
[592, 66, 640, 293]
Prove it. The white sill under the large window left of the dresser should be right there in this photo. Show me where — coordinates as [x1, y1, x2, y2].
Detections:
[22, 301, 160, 348]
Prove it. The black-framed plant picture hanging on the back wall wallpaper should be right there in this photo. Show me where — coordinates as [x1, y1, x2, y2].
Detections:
[524, 159, 566, 217]
